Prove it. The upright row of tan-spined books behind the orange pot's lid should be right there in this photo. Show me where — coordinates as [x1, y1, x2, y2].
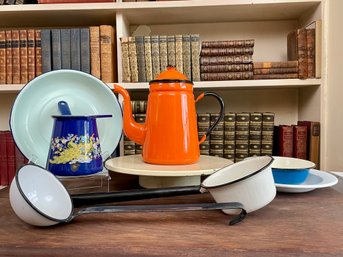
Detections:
[120, 34, 200, 82]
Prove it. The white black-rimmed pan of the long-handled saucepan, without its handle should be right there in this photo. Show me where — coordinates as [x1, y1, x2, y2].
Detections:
[201, 156, 276, 214]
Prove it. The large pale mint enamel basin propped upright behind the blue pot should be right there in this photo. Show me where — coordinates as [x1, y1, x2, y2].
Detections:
[10, 70, 123, 167]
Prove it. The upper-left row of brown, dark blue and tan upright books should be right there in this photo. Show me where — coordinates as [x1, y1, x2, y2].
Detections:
[0, 25, 116, 84]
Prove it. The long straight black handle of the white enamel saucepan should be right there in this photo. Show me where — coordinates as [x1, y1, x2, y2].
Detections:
[71, 186, 201, 207]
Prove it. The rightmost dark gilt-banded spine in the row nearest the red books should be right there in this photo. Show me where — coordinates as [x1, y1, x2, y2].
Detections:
[261, 112, 275, 155]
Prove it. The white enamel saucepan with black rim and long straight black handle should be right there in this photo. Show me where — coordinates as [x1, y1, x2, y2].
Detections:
[73, 156, 276, 214]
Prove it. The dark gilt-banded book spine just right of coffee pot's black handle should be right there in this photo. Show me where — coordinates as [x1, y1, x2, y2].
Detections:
[224, 112, 236, 162]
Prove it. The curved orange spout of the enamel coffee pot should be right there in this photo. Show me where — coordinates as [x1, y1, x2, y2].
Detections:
[113, 85, 146, 145]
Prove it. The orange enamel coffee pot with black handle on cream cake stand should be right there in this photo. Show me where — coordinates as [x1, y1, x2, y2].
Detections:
[114, 66, 224, 165]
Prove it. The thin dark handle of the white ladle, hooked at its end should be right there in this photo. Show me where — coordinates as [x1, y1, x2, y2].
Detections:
[72, 202, 247, 225]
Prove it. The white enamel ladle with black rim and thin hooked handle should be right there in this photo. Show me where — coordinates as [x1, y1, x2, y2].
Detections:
[9, 164, 246, 226]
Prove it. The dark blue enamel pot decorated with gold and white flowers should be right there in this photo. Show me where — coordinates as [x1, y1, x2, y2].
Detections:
[47, 112, 112, 176]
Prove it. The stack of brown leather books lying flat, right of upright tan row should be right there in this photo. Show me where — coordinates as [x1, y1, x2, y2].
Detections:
[200, 39, 255, 81]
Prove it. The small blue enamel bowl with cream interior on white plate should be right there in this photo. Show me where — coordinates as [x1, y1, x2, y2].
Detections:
[271, 156, 316, 185]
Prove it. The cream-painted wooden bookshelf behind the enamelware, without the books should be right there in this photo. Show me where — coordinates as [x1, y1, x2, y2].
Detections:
[0, 0, 342, 169]
